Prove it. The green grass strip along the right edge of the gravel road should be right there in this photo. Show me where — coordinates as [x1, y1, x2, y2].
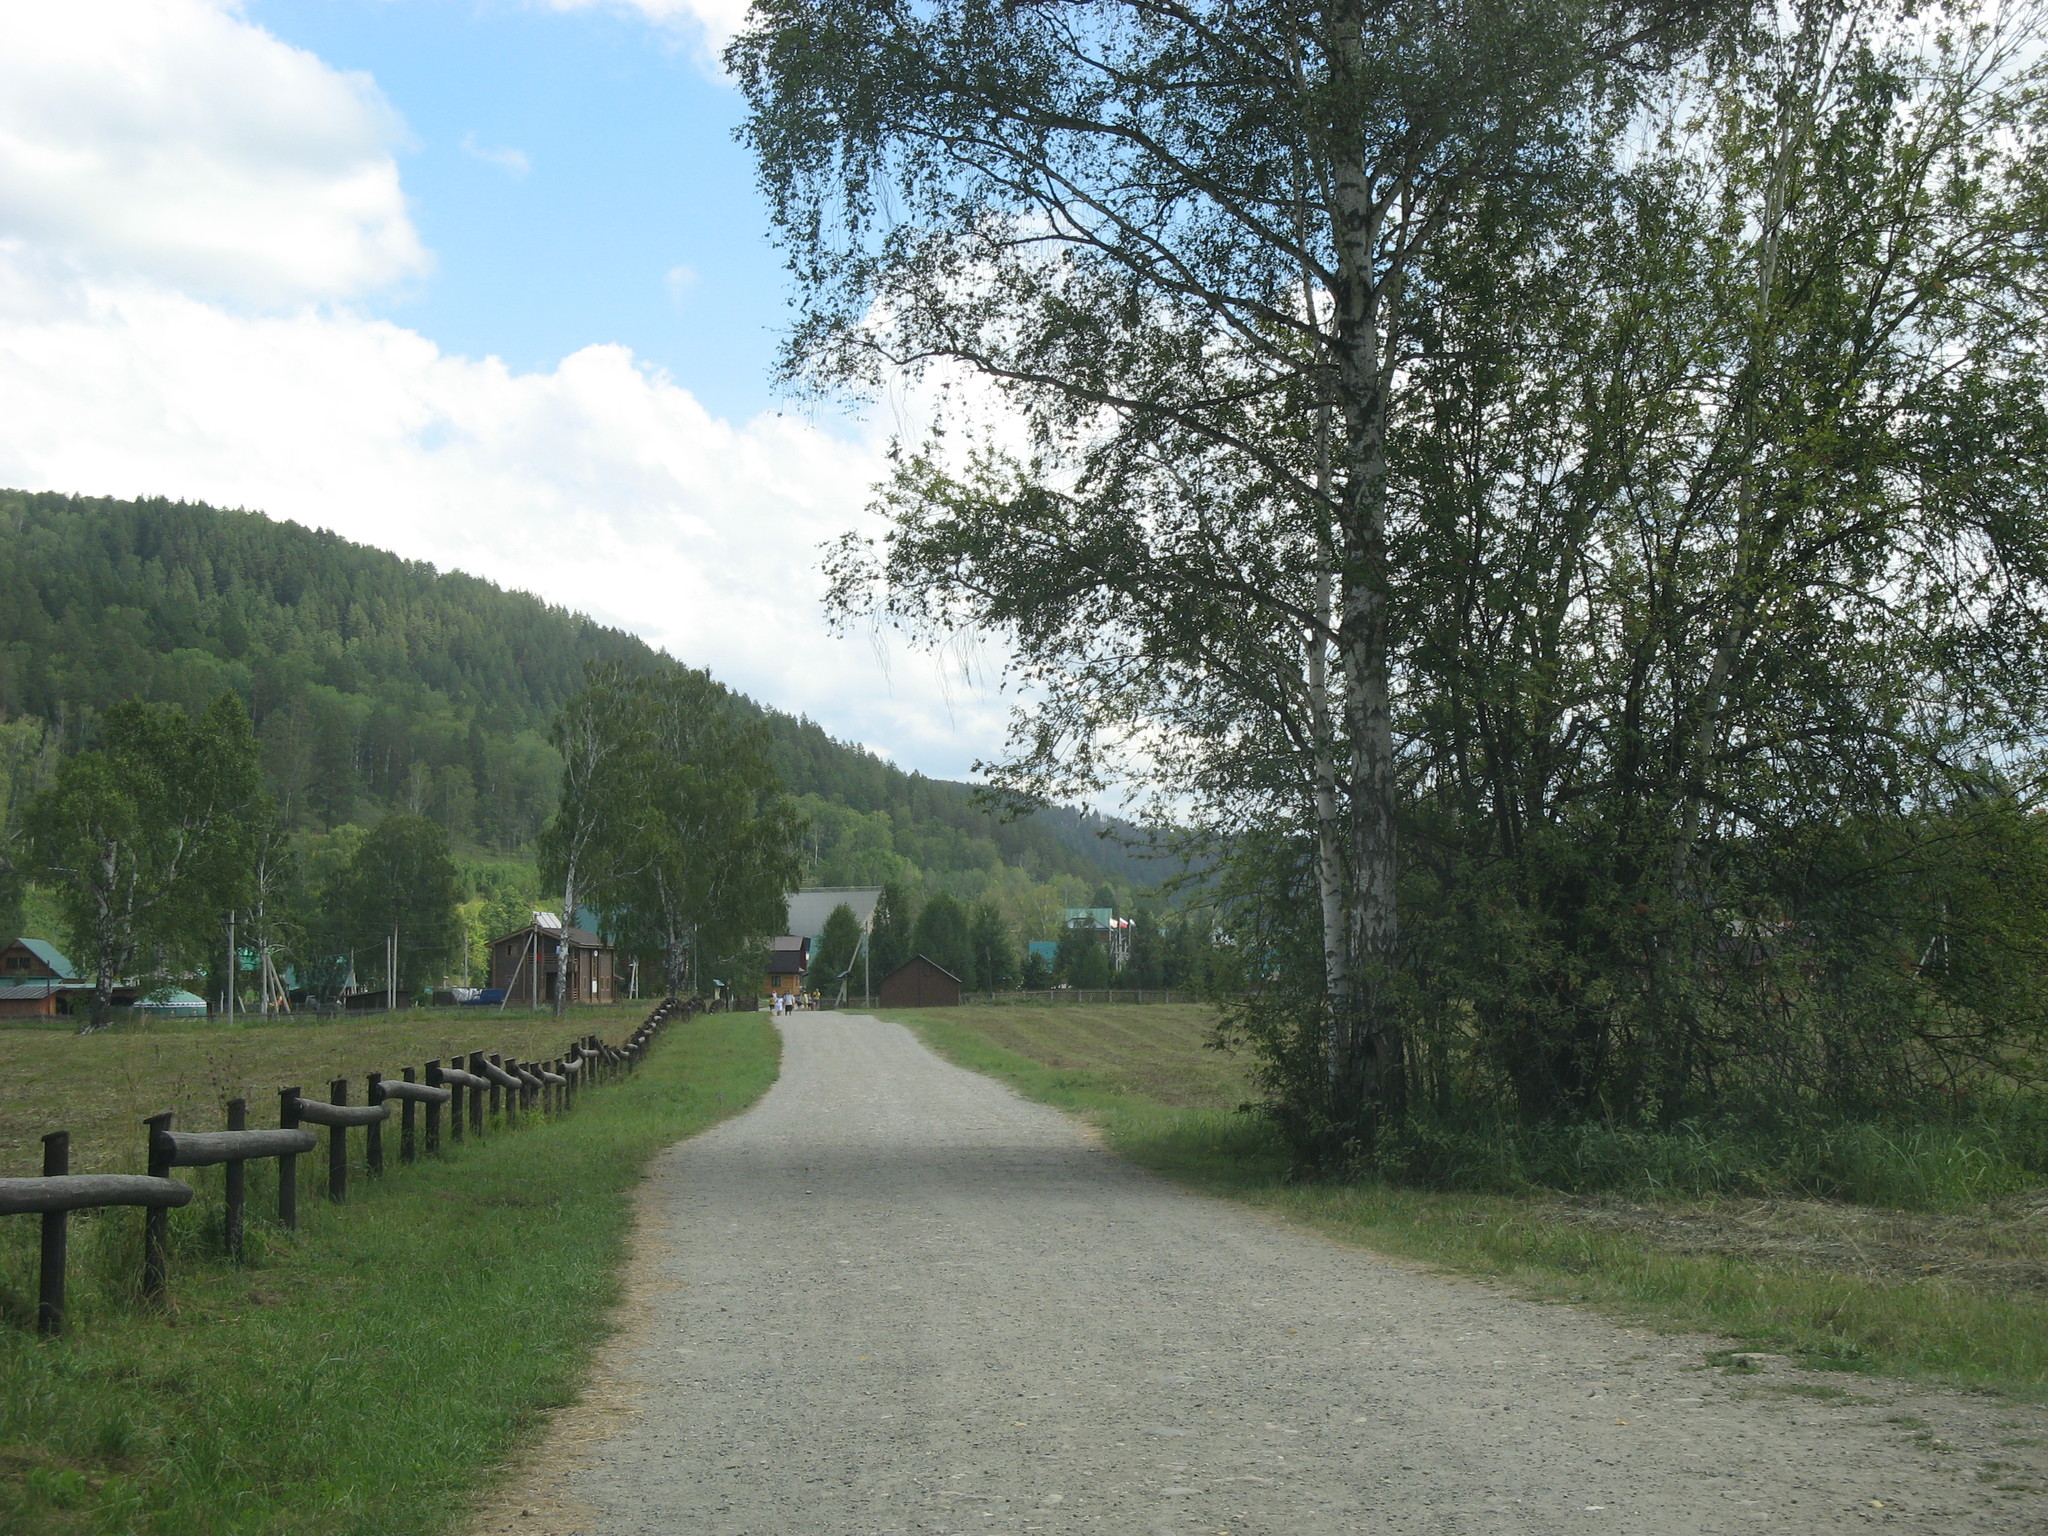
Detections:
[883, 1008, 2048, 1401]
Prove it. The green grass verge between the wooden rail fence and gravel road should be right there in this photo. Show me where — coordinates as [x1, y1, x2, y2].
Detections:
[0, 1010, 780, 1536]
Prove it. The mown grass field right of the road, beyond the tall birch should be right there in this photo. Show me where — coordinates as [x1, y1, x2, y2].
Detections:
[887, 1004, 1251, 1110]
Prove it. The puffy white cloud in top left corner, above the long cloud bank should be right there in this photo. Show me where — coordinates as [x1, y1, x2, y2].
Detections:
[0, 0, 428, 303]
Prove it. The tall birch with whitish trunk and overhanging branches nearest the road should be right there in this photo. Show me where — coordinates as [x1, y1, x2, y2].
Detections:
[745, 0, 1704, 1153]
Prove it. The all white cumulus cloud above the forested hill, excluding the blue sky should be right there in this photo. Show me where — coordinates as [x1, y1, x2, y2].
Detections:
[0, 0, 1001, 774]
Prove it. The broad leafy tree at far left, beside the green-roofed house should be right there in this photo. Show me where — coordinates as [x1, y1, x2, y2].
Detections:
[25, 694, 258, 1028]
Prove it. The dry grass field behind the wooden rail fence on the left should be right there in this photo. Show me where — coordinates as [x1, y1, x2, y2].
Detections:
[0, 1001, 653, 1176]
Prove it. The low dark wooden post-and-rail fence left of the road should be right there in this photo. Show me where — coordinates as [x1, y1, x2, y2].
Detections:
[0, 997, 702, 1335]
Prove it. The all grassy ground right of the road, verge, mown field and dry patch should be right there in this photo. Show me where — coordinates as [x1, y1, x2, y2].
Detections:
[889, 1008, 2048, 1401]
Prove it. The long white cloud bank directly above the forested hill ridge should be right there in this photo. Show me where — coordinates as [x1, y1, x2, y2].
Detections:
[0, 258, 1001, 774]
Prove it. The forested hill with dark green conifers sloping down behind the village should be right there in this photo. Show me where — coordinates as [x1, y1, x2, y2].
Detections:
[0, 492, 1145, 883]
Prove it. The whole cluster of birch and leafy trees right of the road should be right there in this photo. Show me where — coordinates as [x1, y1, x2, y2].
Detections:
[731, 0, 2048, 1159]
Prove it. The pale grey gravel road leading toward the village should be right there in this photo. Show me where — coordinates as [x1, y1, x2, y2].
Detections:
[475, 1014, 2048, 1536]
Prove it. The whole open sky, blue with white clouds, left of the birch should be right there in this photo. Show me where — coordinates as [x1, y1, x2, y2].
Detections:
[0, 0, 1006, 776]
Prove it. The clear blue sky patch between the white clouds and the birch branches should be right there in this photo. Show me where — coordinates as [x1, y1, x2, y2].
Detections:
[248, 0, 784, 416]
